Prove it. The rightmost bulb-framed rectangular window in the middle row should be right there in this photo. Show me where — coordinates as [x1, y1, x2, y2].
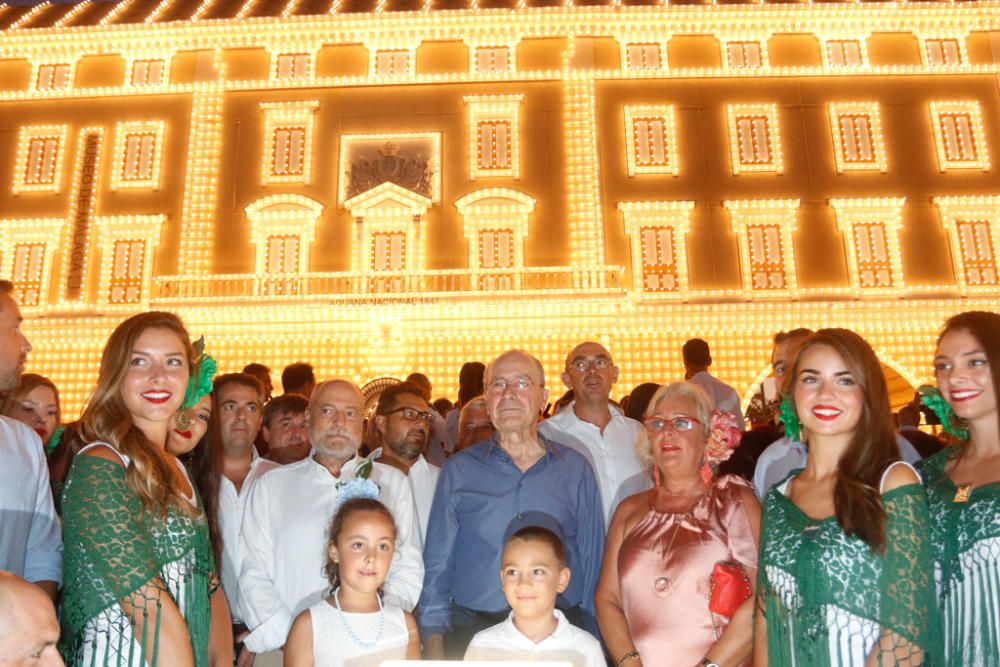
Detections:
[928, 100, 990, 172]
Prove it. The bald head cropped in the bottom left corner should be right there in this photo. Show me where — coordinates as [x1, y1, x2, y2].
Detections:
[0, 571, 63, 667]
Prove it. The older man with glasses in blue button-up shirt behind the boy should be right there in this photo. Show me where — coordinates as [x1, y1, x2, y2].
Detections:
[419, 350, 604, 658]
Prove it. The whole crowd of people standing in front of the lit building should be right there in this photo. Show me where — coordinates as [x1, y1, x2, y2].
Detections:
[0, 274, 1000, 667]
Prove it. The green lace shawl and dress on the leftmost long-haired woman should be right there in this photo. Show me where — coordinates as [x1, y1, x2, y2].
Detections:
[60, 450, 215, 667]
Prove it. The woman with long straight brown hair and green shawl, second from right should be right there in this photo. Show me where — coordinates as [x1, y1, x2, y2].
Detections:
[754, 329, 940, 667]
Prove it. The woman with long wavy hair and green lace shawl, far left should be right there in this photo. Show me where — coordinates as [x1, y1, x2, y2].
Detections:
[60, 312, 232, 667]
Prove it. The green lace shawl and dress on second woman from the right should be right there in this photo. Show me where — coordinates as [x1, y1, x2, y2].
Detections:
[758, 470, 940, 667]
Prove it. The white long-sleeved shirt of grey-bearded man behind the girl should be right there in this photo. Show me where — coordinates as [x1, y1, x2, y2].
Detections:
[239, 456, 424, 653]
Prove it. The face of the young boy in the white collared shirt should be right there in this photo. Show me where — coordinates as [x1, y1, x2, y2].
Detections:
[500, 539, 569, 619]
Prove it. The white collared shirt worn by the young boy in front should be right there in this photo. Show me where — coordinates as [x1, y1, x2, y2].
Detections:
[465, 609, 607, 667]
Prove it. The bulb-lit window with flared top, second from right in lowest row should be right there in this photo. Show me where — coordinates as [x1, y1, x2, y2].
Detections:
[830, 197, 906, 296]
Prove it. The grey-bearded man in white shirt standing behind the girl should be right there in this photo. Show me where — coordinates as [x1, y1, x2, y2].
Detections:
[239, 380, 424, 667]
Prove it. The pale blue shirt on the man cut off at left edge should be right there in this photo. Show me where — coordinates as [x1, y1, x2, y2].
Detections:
[0, 417, 62, 585]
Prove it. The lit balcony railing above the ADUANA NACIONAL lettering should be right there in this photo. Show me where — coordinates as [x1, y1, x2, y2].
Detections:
[150, 266, 623, 302]
